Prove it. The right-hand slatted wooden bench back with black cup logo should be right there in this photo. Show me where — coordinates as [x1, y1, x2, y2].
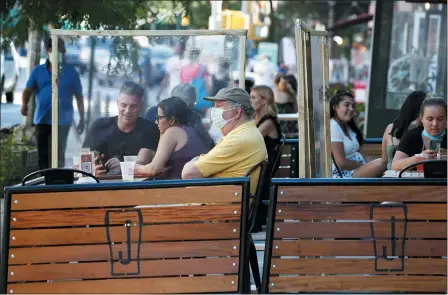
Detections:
[261, 179, 447, 293]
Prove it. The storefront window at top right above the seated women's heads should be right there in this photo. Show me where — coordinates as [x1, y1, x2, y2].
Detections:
[386, 1, 446, 109]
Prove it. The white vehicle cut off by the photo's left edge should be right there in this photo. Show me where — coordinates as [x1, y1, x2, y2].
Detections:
[0, 42, 20, 103]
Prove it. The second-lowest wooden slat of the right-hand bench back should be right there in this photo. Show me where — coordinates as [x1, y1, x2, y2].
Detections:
[271, 258, 447, 275]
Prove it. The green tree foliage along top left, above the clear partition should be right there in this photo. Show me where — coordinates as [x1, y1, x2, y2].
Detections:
[1, 0, 197, 43]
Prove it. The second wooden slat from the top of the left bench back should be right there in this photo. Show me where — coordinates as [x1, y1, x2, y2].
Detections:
[10, 204, 241, 229]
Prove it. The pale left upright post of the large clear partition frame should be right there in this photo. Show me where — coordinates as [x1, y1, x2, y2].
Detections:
[51, 33, 59, 168]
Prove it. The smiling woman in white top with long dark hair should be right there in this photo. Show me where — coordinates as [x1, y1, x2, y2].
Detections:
[330, 91, 387, 178]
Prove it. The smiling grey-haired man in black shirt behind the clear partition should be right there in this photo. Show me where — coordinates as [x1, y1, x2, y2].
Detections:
[83, 82, 160, 174]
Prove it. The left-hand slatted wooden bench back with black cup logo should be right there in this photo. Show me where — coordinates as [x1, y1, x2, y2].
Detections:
[0, 178, 249, 294]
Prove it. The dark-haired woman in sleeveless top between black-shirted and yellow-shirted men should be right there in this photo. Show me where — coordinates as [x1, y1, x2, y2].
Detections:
[136, 97, 210, 179]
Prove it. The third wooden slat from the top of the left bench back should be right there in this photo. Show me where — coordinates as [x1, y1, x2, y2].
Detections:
[9, 222, 240, 247]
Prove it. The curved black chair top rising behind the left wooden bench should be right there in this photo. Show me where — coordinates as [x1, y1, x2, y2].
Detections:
[22, 168, 100, 186]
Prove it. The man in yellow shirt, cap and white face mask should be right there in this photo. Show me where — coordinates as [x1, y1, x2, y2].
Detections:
[182, 87, 267, 193]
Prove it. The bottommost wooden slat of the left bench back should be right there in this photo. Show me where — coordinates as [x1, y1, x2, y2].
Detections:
[7, 276, 238, 294]
